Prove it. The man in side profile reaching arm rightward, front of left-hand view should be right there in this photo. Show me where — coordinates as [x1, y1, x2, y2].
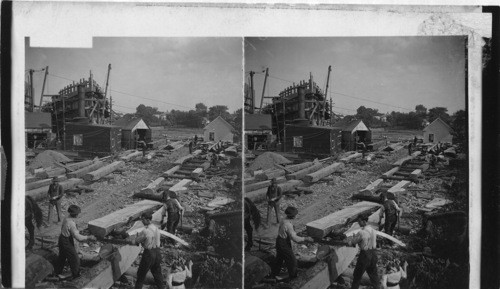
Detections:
[54, 205, 96, 278]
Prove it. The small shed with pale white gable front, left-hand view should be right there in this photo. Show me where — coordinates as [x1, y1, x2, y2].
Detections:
[114, 118, 152, 149]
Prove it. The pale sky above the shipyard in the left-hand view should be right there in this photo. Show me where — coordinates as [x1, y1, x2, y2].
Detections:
[26, 37, 243, 113]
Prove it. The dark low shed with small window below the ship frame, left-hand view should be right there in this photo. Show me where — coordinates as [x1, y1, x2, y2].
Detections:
[64, 123, 121, 154]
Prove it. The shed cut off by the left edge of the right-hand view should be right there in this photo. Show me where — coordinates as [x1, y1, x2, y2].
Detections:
[245, 114, 273, 150]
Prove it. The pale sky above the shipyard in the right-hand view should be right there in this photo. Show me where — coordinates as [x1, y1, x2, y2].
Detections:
[244, 36, 466, 115]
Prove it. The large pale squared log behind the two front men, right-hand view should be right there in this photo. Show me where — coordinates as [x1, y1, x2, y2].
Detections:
[306, 202, 380, 239]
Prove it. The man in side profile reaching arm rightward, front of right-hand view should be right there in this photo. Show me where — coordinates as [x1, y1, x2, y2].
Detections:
[271, 207, 314, 279]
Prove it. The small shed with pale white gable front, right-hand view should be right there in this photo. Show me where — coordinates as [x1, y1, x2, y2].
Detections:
[332, 119, 372, 151]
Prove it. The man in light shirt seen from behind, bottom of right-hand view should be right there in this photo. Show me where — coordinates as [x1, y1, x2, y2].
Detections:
[345, 215, 379, 289]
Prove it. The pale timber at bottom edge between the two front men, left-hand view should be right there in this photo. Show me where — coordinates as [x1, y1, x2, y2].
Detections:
[83, 245, 141, 289]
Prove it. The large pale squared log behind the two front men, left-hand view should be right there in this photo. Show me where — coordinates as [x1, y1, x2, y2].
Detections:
[88, 200, 163, 238]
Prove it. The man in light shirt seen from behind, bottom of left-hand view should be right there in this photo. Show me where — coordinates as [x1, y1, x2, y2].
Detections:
[129, 213, 165, 289]
